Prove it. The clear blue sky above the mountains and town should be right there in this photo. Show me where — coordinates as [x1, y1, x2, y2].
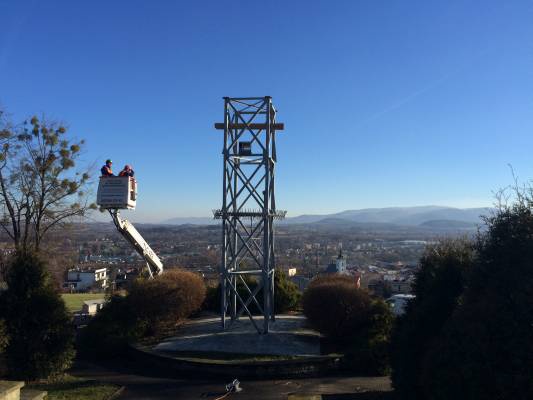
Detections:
[0, 0, 533, 222]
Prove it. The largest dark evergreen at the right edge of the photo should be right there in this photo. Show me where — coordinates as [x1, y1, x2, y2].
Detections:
[422, 203, 533, 400]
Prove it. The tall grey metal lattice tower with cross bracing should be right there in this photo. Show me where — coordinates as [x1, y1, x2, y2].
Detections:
[213, 96, 285, 333]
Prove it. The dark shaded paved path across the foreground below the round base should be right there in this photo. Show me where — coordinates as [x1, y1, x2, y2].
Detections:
[72, 363, 391, 400]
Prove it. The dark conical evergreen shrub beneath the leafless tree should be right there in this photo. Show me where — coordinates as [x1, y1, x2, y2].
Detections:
[0, 252, 75, 381]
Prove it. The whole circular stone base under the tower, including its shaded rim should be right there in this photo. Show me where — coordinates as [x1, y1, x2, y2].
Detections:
[132, 315, 340, 378]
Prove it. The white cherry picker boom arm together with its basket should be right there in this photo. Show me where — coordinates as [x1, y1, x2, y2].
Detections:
[96, 176, 163, 277]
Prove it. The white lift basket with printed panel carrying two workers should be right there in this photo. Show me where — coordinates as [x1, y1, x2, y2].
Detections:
[96, 176, 137, 210]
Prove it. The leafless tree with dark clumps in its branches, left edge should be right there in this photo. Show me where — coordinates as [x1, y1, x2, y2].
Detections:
[0, 112, 96, 251]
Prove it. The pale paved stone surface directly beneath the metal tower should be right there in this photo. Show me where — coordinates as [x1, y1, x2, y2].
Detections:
[153, 315, 320, 356]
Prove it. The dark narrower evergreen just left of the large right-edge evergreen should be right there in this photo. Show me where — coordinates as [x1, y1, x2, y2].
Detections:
[391, 239, 474, 399]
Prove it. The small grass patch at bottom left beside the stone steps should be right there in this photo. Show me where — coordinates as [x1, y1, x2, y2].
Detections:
[27, 375, 120, 400]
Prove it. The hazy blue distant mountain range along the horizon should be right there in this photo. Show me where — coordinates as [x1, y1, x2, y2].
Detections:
[163, 206, 491, 229]
